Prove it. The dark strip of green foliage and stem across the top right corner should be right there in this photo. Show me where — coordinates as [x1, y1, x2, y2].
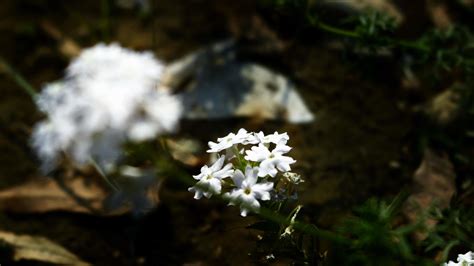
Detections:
[260, 0, 474, 79]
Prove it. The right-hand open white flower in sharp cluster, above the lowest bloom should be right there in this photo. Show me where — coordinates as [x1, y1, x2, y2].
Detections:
[245, 143, 296, 177]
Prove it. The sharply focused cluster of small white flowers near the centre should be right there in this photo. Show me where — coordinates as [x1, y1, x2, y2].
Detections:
[189, 129, 301, 216]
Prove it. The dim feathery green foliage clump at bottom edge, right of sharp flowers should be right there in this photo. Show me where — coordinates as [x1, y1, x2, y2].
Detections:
[329, 196, 429, 265]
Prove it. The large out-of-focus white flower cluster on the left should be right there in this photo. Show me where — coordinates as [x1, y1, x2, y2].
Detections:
[32, 44, 182, 172]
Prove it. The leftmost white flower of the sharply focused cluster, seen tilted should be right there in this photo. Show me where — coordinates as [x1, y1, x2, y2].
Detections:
[188, 156, 234, 199]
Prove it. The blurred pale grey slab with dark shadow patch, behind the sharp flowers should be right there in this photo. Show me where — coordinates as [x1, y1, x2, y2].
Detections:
[162, 40, 314, 123]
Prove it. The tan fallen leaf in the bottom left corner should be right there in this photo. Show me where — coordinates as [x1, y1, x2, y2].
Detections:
[0, 231, 90, 265]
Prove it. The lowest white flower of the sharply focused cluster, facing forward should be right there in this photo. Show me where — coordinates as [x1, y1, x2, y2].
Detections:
[226, 166, 273, 217]
